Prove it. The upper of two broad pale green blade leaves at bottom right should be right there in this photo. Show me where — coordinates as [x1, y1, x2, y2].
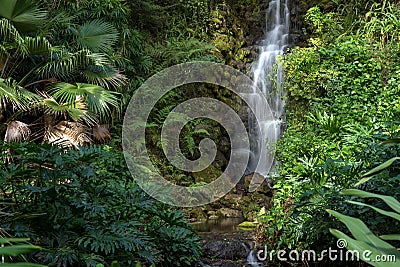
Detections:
[327, 210, 400, 252]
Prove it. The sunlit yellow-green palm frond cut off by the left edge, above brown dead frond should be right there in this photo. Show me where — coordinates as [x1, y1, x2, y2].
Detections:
[0, 78, 40, 110]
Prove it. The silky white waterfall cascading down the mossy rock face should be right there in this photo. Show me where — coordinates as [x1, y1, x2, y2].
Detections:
[248, 0, 290, 176]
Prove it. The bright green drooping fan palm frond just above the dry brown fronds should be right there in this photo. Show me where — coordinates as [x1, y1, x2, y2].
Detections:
[49, 83, 119, 120]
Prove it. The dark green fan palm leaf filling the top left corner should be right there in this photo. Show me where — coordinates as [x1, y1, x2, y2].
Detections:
[0, 0, 47, 32]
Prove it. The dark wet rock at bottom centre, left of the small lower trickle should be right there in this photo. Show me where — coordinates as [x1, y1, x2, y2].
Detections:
[204, 240, 249, 260]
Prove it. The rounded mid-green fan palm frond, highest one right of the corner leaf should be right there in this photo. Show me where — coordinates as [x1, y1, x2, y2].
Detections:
[71, 19, 118, 52]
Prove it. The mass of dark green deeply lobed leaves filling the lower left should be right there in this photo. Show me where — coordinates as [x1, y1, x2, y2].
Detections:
[0, 143, 200, 266]
